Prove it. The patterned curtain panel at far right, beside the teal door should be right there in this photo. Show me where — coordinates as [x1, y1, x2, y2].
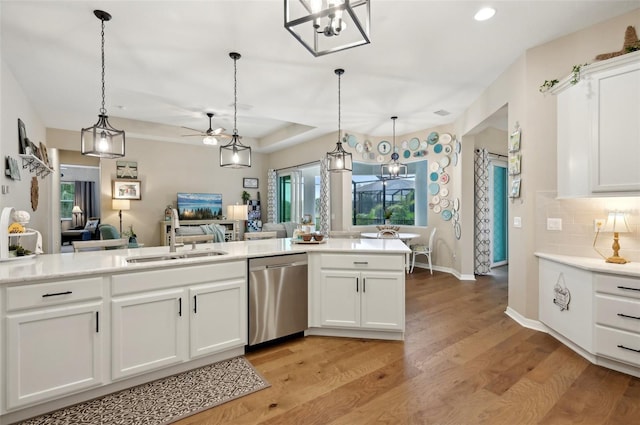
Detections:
[474, 149, 491, 275]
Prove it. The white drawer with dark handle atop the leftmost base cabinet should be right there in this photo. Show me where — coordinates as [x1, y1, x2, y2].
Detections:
[7, 277, 102, 311]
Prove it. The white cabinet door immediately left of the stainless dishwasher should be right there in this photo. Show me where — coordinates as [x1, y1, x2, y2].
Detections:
[189, 279, 247, 357]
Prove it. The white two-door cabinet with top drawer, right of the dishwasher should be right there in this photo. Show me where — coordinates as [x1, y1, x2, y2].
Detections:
[310, 254, 404, 332]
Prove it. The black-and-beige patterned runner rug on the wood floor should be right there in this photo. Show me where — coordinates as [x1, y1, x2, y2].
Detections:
[19, 357, 271, 425]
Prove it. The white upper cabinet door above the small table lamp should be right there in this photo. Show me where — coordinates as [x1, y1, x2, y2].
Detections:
[592, 61, 640, 194]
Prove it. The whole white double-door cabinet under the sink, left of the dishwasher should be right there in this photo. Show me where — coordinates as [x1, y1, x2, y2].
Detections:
[111, 261, 247, 379]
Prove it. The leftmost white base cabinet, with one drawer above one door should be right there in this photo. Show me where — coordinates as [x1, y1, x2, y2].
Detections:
[5, 278, 105, 410]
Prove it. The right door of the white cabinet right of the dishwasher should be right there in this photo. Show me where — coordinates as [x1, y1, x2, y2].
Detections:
[361, 272, 404, 330]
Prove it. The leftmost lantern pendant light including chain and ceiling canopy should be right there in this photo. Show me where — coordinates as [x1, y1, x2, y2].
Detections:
[80, 10, 124, 158]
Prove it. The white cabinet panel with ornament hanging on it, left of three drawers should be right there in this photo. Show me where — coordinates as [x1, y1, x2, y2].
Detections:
[539, 259, 593, 352]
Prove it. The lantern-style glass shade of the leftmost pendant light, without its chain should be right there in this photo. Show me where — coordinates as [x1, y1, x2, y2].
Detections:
[81, 115, 125, 158]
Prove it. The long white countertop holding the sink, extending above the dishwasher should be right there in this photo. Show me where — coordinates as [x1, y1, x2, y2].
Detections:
[0, 238, 410, 284]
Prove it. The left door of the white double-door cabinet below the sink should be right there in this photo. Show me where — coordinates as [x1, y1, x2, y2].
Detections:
[111, 289, 189, 379]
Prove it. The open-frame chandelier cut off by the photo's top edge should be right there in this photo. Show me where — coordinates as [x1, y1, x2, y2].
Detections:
[284, 0, 371, 57]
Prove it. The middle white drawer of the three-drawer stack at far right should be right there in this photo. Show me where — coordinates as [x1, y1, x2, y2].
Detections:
[596, 294, 640, 333]
